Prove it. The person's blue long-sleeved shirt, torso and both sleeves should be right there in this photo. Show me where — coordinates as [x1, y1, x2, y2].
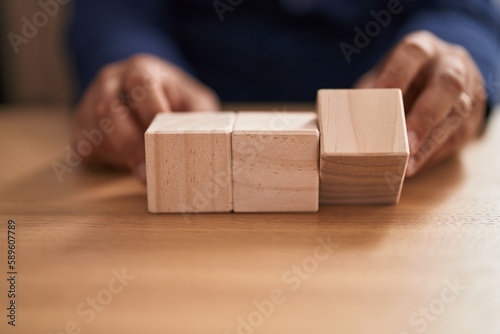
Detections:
[70, 0, 500, 103]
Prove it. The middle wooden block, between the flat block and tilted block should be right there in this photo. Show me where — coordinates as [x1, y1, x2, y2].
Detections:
[232, 112, 319, 212]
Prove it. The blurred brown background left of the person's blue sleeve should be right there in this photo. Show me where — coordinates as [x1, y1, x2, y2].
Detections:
[0, 0, 500, 105]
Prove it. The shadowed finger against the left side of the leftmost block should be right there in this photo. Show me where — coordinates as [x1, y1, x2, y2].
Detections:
[109, 102, 146, 183]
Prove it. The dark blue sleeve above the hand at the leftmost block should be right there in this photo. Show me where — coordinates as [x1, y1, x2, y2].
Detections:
[68, 0, 191, 93]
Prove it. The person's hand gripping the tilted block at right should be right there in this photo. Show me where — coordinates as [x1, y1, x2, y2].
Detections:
[356, 31, 486, 176]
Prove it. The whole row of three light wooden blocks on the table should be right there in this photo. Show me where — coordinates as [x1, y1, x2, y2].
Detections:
[145, 89, 409, 213]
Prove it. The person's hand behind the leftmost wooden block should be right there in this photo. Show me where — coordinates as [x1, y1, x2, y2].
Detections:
[73, 55, 220, 182]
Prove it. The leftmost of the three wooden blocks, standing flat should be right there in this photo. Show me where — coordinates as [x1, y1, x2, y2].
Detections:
[145, 112, 235, 212]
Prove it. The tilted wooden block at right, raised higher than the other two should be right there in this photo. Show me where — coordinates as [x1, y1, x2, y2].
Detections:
[317, 89, 410, 204]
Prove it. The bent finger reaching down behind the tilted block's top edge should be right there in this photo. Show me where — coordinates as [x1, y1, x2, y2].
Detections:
[374, 32, 437, 95]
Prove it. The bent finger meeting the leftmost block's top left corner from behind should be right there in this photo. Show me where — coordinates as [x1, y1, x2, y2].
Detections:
[123, 71, 171, 130]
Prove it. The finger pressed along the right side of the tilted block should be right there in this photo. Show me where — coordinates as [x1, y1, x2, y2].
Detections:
[407, 56, 467, 155]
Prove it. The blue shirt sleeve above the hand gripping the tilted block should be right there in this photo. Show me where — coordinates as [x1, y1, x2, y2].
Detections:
[393, 0, 500, 106]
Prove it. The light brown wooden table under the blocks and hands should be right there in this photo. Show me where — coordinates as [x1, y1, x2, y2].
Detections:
[0, 108, 500, 334]
